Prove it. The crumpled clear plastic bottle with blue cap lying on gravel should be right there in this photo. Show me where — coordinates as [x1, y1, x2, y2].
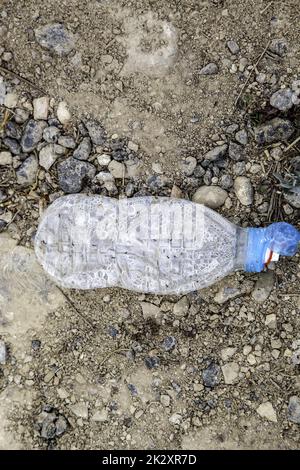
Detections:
[35, 194, 300, 294]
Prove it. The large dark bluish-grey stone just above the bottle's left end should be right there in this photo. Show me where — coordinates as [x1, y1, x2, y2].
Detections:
[58, 157, 96, 194]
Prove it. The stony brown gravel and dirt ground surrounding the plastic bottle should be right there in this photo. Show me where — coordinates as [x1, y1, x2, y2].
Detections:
[0, 0, 300, 449]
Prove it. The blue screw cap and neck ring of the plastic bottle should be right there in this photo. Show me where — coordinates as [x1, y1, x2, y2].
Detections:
[245, 222, 300, 273]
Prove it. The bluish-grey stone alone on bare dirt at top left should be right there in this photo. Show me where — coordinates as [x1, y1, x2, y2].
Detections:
[35, 23, 75, 56]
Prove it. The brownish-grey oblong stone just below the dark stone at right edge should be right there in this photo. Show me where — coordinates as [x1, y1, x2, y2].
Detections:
[254, 118, 295, 145]
